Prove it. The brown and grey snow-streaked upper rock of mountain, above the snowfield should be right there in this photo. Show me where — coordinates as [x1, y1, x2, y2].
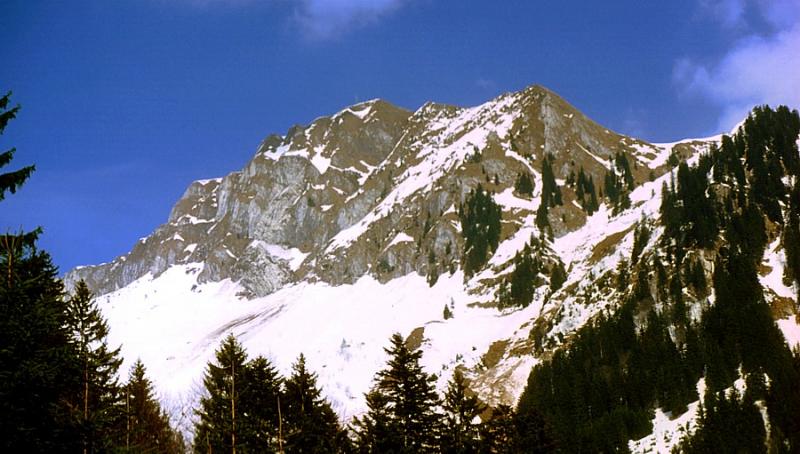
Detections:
[65, 86, 688, 297]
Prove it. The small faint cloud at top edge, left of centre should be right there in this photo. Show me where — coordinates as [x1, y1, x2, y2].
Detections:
[294, 0, 406, 40]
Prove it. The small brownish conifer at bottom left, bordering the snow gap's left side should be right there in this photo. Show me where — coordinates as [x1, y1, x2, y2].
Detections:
[124, 360, 183, 453]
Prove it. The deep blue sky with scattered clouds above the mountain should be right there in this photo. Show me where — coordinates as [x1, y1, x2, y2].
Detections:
[0, 0, 800, 271]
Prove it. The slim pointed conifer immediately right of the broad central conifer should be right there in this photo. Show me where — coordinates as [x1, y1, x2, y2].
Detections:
[441, 369, 486, 454]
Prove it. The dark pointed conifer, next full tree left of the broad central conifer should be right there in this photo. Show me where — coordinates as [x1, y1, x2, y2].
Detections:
[281, 354, 344, 454]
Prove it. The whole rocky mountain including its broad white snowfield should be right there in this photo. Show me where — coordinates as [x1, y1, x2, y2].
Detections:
[65, 86, 800, 450]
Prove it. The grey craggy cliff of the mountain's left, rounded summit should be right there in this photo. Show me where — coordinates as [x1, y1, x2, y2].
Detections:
[66, 101, 410, 296]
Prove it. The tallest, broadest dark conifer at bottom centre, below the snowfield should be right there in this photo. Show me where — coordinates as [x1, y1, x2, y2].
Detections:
[356, 333, 439, 453]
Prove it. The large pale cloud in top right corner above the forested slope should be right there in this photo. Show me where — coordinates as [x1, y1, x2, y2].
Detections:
[673, 0, 800, 131]
